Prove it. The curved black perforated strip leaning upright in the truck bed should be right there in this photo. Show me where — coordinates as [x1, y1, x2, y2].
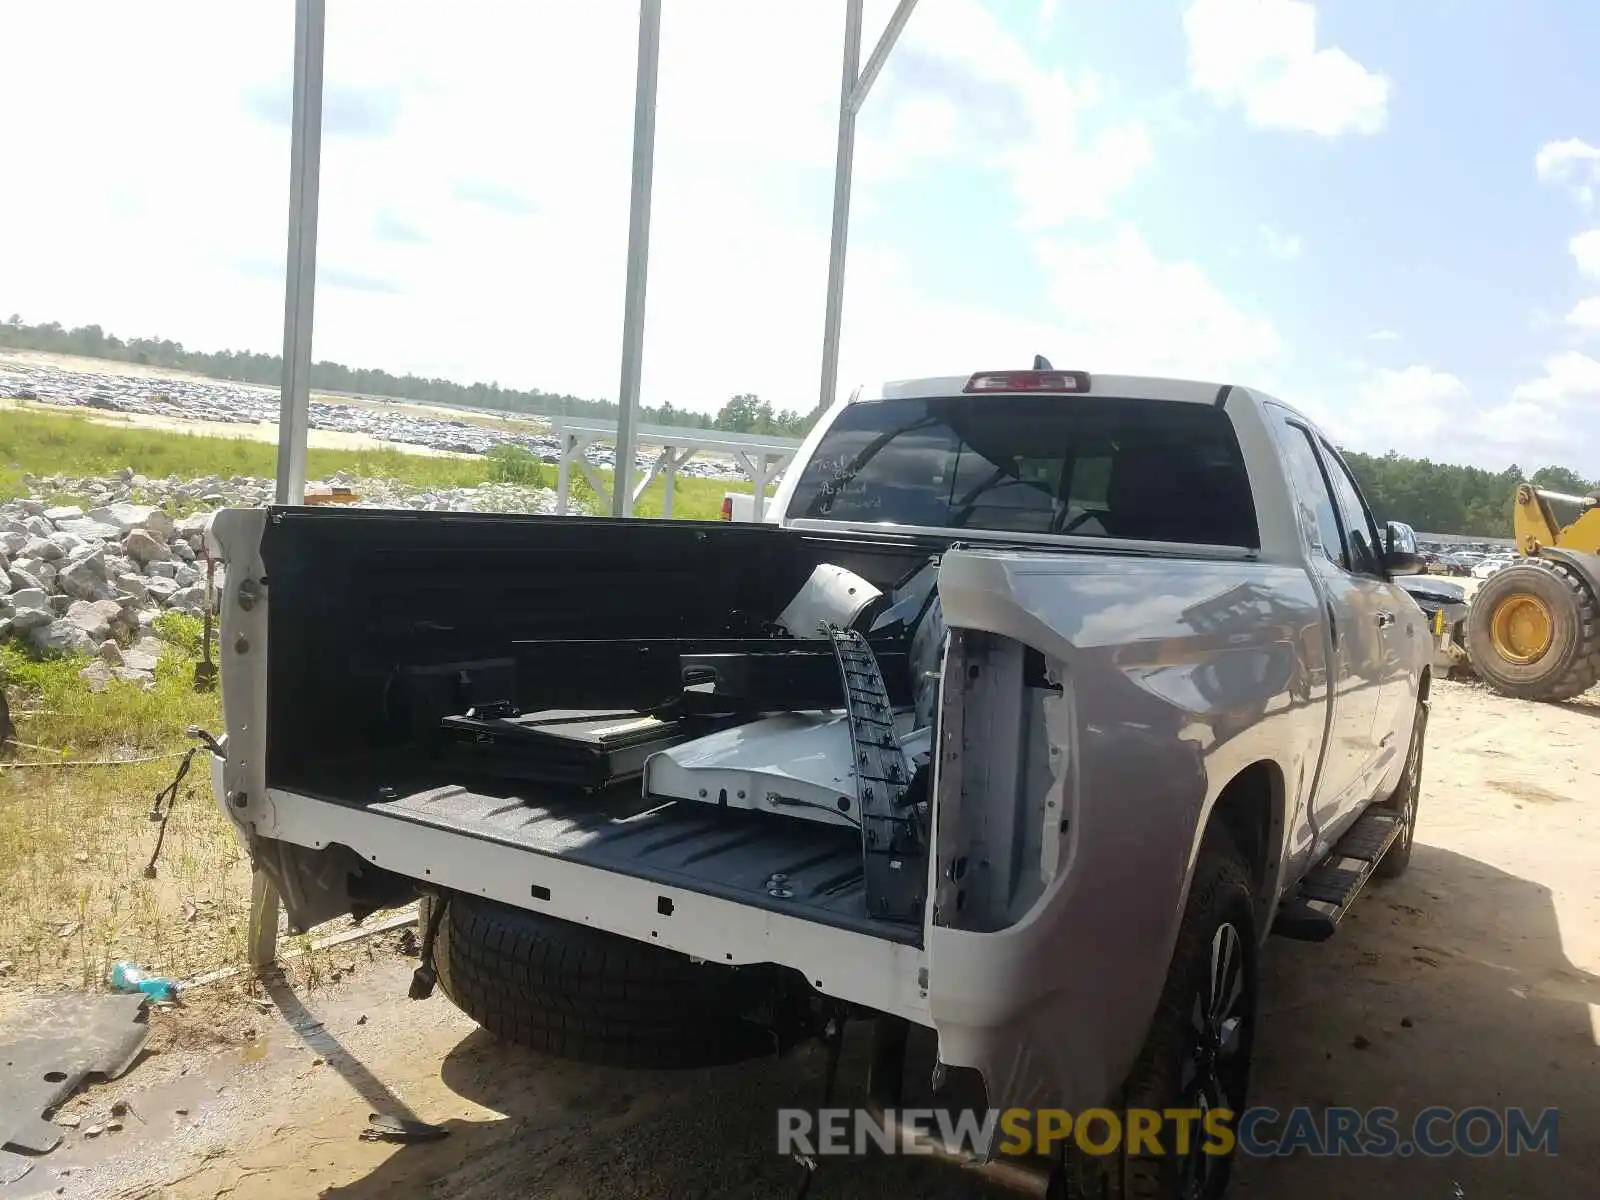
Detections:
[827, 626, 926, 922]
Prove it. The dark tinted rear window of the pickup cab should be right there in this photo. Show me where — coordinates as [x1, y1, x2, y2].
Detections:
[789, 395, 1258, 549]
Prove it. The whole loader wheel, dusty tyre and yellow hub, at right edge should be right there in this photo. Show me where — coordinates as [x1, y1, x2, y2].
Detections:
[1467, 558, 1600, 701]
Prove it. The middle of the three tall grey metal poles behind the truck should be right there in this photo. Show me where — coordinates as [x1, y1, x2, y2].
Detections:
[611, 0, 662, 517]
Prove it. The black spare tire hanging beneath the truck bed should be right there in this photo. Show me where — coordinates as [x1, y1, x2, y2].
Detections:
[421, 894, 774, 1069]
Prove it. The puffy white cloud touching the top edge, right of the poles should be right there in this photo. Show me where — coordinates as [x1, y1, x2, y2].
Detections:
[1184, 0, 1390, 138]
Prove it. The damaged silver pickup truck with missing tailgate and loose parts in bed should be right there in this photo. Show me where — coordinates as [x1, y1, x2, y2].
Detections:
[208, 362, 1432, 1200]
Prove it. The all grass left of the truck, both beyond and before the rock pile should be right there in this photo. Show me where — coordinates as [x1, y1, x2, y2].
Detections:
[0, 408, 768, 1002]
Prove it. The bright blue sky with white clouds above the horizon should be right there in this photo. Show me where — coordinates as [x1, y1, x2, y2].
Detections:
[0, 0, 1600, 478]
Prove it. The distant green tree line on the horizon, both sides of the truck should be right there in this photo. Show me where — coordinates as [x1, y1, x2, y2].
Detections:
[0, 315, 1597, 538]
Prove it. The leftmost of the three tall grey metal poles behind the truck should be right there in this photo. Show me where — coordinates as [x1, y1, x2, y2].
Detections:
[275, 0, 328, 504]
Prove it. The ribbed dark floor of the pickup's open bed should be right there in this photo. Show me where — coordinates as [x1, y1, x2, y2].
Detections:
[286, 758, 922, 946]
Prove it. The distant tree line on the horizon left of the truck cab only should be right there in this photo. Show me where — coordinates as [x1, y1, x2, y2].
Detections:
[0, 314, 816, 437]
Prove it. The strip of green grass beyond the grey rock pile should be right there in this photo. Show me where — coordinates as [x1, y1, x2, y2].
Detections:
[0, 408, 750, 520]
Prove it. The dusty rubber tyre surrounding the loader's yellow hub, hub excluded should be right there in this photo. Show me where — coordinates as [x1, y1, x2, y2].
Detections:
[1467, 558, 1600, 701]
